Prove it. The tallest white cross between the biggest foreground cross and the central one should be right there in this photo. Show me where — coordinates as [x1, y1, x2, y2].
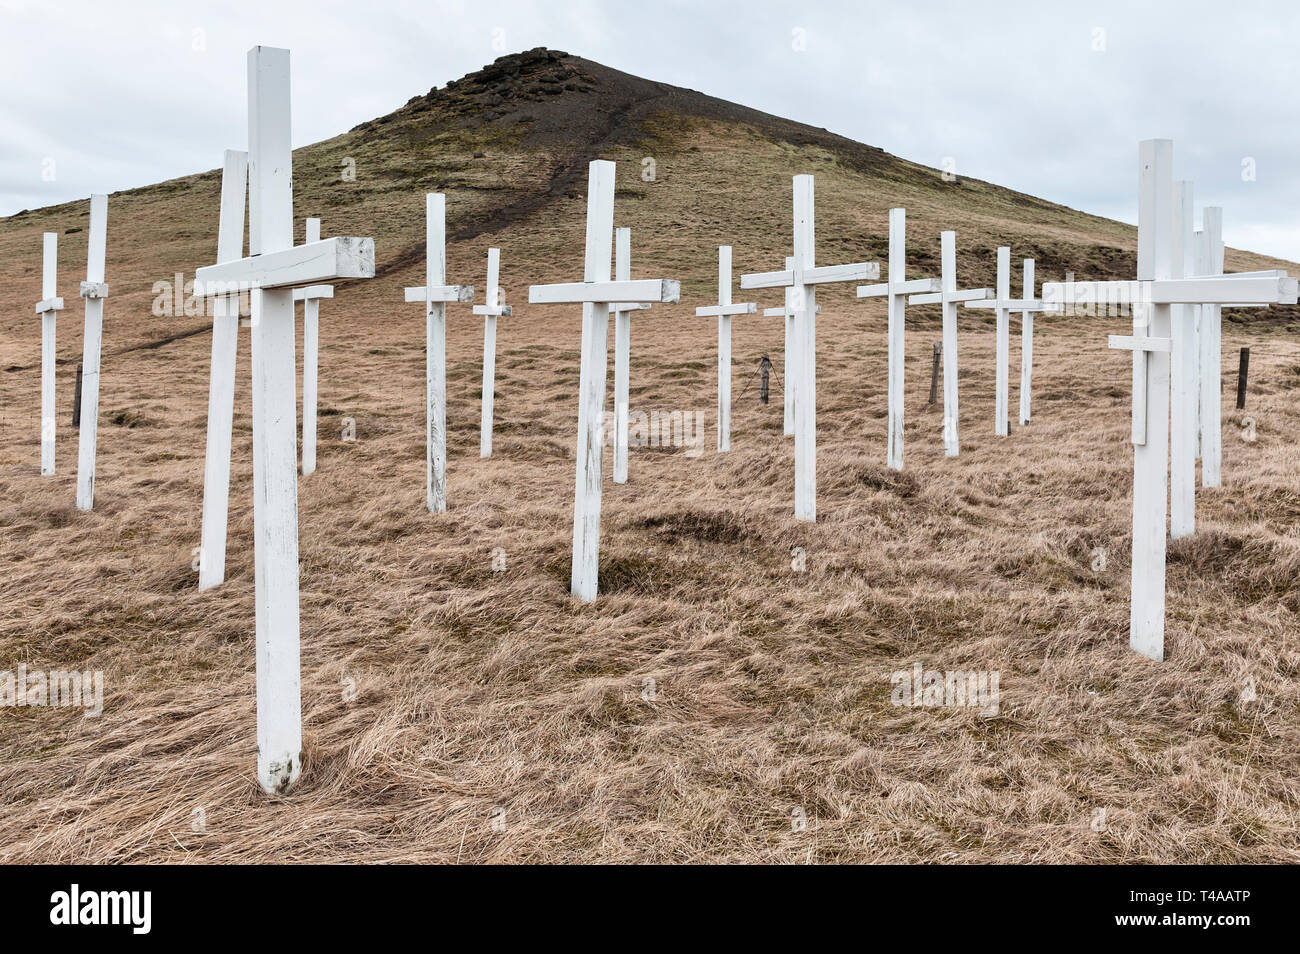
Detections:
[406, 192, 475, 513]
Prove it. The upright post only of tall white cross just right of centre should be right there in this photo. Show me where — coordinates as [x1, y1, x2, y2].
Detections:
[792, 175, 816, 521]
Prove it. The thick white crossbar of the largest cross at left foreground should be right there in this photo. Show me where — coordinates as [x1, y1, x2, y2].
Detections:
[194, 237, 374, 295]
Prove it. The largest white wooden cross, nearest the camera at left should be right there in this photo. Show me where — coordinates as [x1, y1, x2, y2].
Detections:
[195, 47, 374, 793]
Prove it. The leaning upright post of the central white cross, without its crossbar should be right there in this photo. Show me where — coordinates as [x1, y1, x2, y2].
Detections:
[569, 160, 614, 603]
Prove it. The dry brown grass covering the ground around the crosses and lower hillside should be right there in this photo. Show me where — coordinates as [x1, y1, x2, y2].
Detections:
[0, 55, 1300, 863]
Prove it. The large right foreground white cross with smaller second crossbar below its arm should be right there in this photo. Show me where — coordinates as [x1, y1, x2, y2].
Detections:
[1043, 139, 1297, 660]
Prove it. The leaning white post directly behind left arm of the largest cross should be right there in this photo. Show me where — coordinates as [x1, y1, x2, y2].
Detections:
[199, 149, 248, 590]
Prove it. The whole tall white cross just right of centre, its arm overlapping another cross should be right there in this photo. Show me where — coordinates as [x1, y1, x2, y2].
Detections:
[740, 175, 880, 521]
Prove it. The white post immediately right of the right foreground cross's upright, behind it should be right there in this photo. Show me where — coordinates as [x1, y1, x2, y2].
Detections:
[1169, 182, 1200, 539]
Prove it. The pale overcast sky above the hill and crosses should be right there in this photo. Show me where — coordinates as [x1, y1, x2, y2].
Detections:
[0, 0, 1300, 261]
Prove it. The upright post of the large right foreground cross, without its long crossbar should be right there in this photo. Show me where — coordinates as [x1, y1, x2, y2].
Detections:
[1128, 139, 1174, 660]
